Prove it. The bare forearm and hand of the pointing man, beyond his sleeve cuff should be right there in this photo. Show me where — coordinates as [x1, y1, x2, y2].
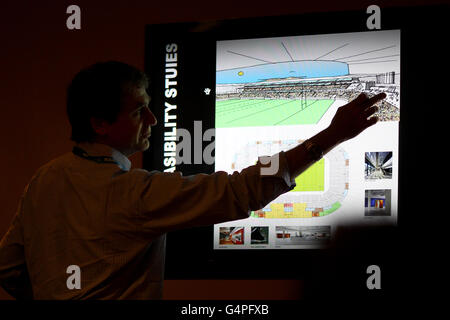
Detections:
[285, 93, 386, 177]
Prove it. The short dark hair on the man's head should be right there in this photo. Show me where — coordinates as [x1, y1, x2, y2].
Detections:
[67, 61, 149, 142]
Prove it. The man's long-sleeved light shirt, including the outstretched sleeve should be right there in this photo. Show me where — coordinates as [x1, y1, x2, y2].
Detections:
[0, 143, 295, 299]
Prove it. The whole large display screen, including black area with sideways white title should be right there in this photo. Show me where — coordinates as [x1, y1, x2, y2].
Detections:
[143, 10, 408, 278]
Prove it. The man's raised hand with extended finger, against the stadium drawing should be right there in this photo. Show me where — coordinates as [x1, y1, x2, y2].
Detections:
[329, 93, 386, 143]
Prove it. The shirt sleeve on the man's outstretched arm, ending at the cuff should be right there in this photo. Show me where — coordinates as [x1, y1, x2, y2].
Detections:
[132, 152, 295, 238]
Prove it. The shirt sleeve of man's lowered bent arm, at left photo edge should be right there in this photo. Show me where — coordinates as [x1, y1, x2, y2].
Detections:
[0, 189, 33, 299]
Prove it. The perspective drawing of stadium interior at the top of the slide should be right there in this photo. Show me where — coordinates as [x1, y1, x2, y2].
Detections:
[216, 30, 400, 128]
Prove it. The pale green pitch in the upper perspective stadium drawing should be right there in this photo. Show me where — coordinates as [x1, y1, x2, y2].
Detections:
[216, 99, 334, 128]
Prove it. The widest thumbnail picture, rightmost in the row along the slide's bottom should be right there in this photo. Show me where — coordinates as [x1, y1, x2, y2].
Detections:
[275, 226, 331, 245]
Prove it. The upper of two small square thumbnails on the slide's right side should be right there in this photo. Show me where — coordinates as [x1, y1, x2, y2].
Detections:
[364, 152, 392, 180]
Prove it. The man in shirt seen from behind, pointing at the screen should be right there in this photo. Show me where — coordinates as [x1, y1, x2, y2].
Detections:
[0, 62, 384, 299]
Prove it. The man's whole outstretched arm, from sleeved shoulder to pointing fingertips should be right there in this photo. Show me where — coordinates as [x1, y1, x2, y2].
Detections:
[130, 95, 384, 239]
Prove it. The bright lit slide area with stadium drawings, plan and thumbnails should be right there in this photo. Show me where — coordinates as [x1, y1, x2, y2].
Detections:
[211, 30, 401, 250]
